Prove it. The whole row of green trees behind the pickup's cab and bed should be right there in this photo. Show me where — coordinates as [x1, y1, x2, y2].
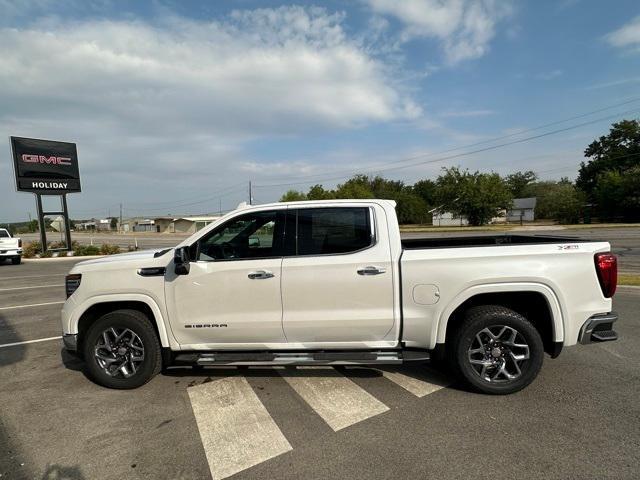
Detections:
[280, 120, 640, 225]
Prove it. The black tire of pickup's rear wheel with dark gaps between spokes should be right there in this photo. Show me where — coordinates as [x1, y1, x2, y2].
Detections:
[450, 305, 544, 395]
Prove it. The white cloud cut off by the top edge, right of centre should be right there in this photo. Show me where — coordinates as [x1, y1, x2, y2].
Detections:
[365, 0, 512, 64]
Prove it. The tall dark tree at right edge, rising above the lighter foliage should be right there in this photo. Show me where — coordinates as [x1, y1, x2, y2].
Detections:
[576, 120, 640, 200]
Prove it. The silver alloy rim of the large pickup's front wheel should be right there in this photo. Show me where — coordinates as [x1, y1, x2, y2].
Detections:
[94, 327, 144, 378]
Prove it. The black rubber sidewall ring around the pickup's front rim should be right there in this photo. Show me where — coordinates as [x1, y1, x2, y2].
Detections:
[83, 311, 160, 389]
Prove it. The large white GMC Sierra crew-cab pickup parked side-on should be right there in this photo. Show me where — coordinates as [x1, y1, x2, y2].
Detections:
[62, 200, 617, 394]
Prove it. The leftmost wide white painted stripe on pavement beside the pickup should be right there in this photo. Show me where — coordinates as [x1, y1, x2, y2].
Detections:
[187, 377, 292, 479]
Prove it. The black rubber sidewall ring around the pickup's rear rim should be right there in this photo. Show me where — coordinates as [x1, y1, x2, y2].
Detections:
[455, 311, 544, 395]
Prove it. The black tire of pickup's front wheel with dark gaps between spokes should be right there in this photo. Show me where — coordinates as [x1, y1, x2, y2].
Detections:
[82, 309, 162, 390]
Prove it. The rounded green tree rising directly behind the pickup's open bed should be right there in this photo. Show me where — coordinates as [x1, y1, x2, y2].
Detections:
[436, 167, 513, 225]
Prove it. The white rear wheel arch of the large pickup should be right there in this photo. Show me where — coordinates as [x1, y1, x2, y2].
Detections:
[437, 283, 564, 357]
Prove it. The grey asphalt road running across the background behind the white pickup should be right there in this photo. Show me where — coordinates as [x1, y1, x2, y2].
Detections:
[22, 226, 640, 275]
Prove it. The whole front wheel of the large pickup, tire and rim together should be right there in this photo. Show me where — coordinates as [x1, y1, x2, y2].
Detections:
[83, 309, 162, 389]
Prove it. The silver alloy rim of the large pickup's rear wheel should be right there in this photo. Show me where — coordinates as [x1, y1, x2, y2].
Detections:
[467, 325, 530, 383]
